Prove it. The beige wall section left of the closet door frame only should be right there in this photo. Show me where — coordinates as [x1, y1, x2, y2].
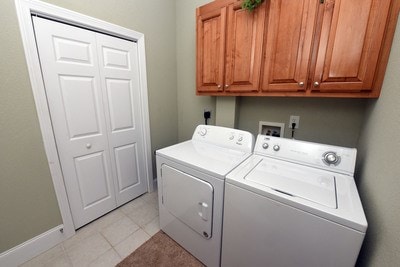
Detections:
[0, 0, 62, 253]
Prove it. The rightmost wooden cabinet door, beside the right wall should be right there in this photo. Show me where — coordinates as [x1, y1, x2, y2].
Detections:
[312, 0, 390, 92]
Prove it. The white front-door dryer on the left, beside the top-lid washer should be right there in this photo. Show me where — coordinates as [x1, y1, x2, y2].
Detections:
[156, 125, 254, 266]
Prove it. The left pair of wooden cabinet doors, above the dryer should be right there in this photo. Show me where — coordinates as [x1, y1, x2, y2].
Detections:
[196, 0, 265, 93]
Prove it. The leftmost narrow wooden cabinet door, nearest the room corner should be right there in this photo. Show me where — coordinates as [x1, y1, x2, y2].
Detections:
[196, 2, 227, 92]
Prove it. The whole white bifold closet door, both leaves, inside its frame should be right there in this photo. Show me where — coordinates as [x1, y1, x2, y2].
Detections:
[33, 17, 147, 228]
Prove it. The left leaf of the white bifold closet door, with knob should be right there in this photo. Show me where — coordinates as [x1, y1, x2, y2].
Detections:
[33, 17, 116, 228]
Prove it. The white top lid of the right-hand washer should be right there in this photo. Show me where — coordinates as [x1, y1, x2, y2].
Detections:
[245, 159, 337, 209]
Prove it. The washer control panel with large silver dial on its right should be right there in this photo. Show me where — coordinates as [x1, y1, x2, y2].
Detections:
[254, 135, 357, 174]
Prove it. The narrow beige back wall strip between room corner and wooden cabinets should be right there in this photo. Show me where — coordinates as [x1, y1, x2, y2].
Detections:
[176, 0, 216, 141]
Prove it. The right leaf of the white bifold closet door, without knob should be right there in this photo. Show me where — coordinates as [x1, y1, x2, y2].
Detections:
[96, 34, 147, 206]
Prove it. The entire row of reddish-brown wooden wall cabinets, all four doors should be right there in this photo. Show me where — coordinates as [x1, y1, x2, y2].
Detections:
[197, 0, 400, 98]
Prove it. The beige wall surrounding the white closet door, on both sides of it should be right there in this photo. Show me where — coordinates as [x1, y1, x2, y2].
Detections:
[0, 0, 178, 253]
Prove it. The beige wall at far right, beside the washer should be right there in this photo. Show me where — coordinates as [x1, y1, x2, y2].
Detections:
[356, 17, 400, 266]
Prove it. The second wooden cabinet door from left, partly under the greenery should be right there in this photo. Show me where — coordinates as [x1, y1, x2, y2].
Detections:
[224, 2, 265, 92]
